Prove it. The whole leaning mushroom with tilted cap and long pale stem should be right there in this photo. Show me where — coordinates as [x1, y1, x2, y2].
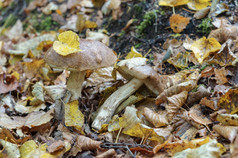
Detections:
[92, 57, 171, 130]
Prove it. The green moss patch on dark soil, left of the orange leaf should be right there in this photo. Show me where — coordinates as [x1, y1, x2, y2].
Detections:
[136, 10, 158, 36]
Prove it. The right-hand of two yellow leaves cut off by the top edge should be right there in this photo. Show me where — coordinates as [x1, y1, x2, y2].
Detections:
[187, 0, 211, 10]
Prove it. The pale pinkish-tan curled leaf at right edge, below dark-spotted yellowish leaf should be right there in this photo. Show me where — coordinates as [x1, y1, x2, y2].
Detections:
[212, 125, 237, 143]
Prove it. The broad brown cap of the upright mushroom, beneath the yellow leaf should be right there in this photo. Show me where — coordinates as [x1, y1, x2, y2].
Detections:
[44, 39, 117, 71]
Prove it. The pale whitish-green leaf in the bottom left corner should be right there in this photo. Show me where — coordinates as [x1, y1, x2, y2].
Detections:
[0, 139, 21, 158]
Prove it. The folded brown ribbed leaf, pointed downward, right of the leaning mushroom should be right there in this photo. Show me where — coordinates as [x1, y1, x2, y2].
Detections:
[165, 91, 188, 121]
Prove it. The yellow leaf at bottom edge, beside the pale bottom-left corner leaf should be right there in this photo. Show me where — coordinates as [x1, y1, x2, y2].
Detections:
[20, 140, 57, 158]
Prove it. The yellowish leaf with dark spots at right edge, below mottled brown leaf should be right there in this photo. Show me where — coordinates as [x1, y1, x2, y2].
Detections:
[217, 114, 238, 126]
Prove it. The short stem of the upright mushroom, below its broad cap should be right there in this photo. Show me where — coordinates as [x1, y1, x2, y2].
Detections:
[67, 71, 86, 101]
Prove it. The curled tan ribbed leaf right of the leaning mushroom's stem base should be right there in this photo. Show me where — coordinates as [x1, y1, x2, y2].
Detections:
[143, 108, 168, 127]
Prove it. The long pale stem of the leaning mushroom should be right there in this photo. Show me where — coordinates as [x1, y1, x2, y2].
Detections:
[92, 78, 143, 130]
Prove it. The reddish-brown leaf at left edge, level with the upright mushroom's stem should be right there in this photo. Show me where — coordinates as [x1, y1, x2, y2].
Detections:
[0, 73, 18, 94]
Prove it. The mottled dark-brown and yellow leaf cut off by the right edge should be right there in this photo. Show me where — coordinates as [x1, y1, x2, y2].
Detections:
[217, 88, 238, 114]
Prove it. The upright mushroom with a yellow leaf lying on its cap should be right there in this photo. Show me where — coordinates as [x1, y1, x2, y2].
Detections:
[44, 39, 117, 101]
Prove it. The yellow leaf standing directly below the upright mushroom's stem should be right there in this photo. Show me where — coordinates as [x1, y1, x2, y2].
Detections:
[65, 100, 84, 132]
